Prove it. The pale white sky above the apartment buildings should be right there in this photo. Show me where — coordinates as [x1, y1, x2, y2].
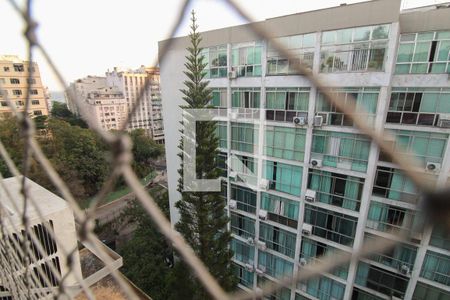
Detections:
[0, 0, 445, 91]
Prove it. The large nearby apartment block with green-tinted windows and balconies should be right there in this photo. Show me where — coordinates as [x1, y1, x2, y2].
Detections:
[160, 0, 450, 300]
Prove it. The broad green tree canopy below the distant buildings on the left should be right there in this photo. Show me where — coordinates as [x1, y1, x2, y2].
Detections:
[0, 116, 162, 201]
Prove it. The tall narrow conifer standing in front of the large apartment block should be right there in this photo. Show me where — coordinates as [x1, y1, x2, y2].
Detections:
[175, 12, 236, 299]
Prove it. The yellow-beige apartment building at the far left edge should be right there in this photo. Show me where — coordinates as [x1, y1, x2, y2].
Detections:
[0, 55, 48, 117]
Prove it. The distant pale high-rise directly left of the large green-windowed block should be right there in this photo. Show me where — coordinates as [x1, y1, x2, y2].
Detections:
[106, 66, 164, 143]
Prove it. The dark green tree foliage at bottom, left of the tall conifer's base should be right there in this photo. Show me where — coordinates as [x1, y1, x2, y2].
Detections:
[119, 189, 174, 300]
